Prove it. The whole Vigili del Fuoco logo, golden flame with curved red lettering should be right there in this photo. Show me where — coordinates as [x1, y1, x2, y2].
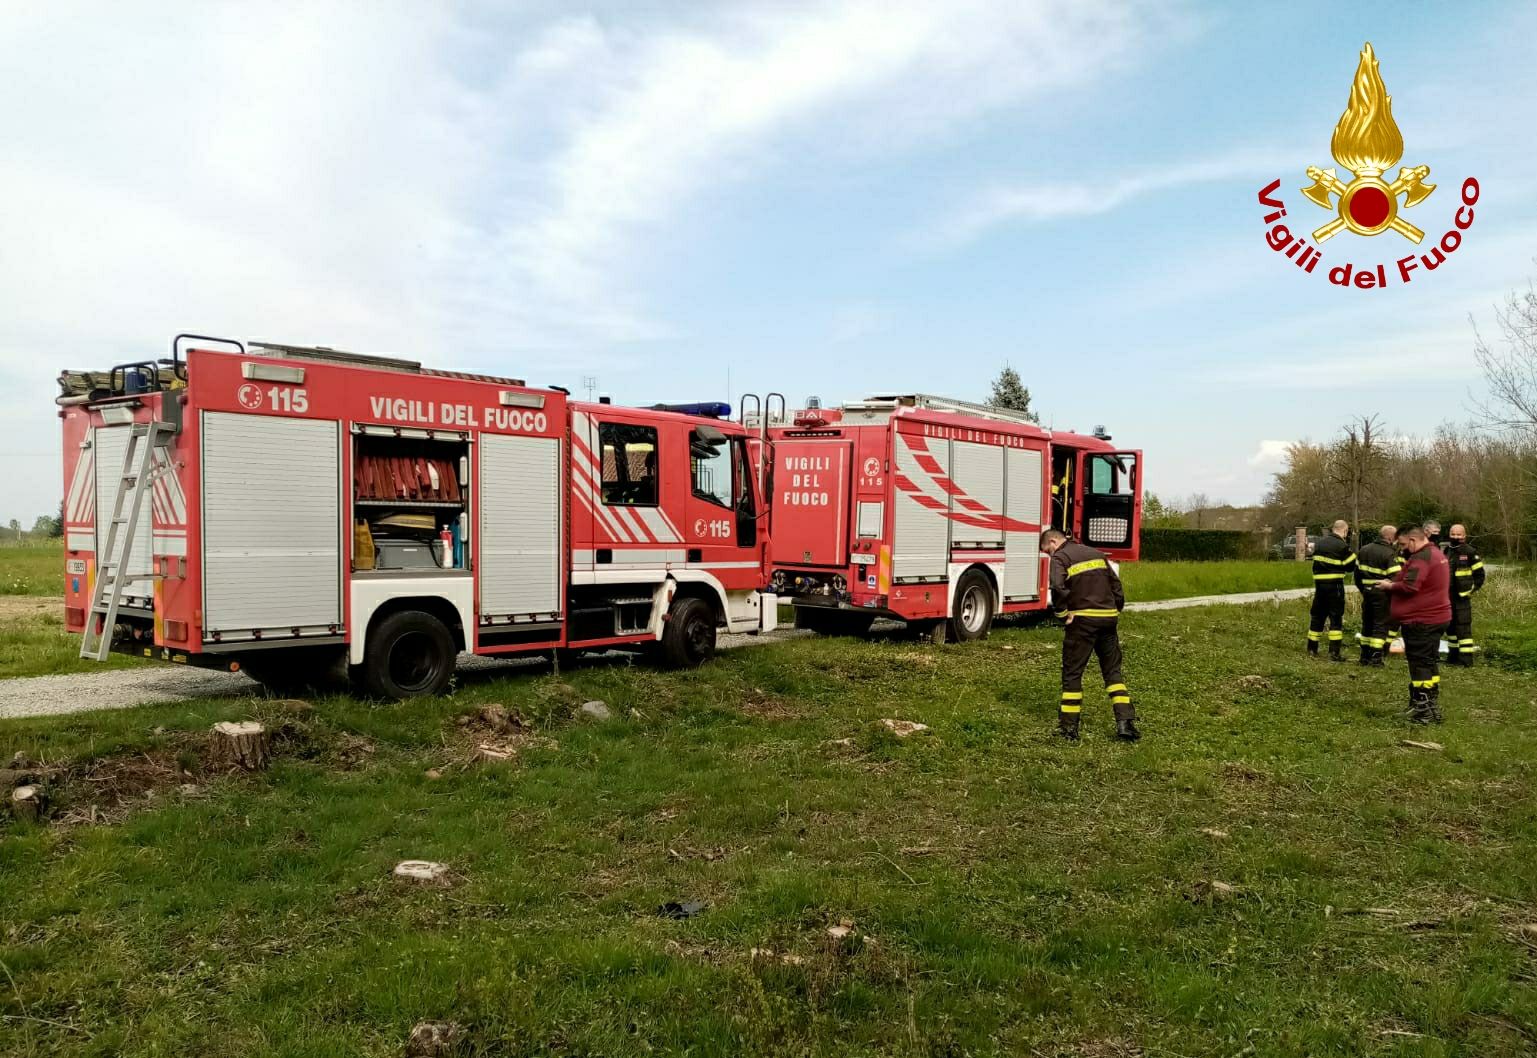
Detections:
[1259, 43, 1479, 291]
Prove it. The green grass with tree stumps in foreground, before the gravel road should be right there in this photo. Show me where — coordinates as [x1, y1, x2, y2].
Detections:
[0, 572, 1537, 1058]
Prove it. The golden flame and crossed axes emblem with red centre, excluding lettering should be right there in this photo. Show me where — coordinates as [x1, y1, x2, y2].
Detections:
[1302, 42, 1436, 243]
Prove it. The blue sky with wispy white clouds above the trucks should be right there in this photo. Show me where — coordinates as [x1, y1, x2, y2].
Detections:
[0, 0, 1537, 524]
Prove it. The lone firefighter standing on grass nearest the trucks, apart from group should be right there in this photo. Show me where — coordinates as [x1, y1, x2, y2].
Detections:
[1041, 529, 1142, 741]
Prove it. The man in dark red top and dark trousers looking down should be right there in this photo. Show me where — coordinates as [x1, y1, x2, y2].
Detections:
[1373, 526, 1451, 724]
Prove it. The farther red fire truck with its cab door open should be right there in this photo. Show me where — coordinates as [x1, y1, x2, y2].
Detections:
[770, 394, 1142, 640]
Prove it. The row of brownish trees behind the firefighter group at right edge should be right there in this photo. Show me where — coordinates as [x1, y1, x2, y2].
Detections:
[1265, 288, 1537, 557]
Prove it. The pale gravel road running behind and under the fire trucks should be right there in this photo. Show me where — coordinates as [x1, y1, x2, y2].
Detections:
[0, 587, 1313, 720]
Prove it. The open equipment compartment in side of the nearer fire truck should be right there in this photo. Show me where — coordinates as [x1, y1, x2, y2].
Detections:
[352, 424, 472, 572]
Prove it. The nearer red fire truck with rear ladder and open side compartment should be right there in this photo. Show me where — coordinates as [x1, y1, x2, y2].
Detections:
[58, 335, 776, 697]
